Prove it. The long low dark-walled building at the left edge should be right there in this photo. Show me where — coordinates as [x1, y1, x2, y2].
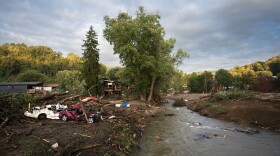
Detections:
[0, 82, 43, 94]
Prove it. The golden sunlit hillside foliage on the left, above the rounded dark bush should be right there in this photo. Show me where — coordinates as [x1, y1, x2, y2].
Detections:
[0, 43, 81, 81]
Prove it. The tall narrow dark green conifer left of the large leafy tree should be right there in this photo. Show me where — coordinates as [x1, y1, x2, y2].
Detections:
[81, 26, 100, 95]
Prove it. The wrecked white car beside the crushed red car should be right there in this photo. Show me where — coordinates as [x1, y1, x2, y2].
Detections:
[24, 104, 67, 119]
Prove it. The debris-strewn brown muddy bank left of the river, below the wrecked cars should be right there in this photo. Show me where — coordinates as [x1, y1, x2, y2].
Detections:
[0, 101, 161, 155]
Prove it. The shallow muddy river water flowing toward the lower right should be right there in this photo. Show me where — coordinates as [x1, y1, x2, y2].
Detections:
[131, 100, 280, 156]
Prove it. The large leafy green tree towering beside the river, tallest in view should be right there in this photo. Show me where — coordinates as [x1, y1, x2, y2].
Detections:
[103, 7, 186, 101]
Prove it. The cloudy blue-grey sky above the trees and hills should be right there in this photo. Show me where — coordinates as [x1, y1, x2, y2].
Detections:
[0, 0, 280, 73]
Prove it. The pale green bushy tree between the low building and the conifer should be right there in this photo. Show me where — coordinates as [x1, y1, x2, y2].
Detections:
[56, 70, 85, 94]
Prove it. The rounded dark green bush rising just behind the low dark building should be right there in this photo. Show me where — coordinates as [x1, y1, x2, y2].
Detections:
[16, 70, 48, 82]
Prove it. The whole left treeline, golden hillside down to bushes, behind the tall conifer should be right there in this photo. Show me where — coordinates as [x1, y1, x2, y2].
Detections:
[0, 43, 108, 92]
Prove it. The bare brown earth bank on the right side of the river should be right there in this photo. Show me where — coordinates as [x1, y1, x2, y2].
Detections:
[166, 93, 280, 132]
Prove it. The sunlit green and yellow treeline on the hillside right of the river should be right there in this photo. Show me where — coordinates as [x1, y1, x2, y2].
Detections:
[184, 55, 280, 92]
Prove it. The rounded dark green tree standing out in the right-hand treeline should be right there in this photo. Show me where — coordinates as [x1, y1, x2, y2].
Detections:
[215, 69, 233, 87]
